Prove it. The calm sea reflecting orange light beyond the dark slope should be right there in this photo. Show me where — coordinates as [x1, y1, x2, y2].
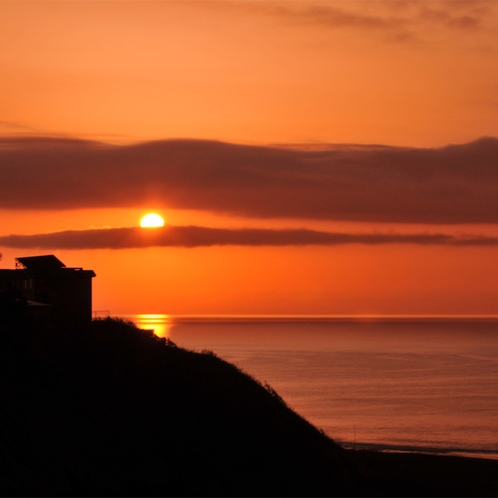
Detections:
[122, 315, 498, 459]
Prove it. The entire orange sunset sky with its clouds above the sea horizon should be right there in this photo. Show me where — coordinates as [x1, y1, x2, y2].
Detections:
[0, 0, 498, 315]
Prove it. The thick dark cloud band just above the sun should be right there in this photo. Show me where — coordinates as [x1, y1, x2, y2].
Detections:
[0, 138, 498, 223]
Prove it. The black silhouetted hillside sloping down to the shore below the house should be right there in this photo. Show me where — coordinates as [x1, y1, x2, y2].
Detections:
[0, 319, 498, 496]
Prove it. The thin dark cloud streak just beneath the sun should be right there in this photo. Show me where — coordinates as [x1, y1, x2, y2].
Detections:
[0, 225, 498, 250]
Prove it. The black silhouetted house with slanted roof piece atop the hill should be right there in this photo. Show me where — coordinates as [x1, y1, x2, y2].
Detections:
[0, 255, 95, 324]
